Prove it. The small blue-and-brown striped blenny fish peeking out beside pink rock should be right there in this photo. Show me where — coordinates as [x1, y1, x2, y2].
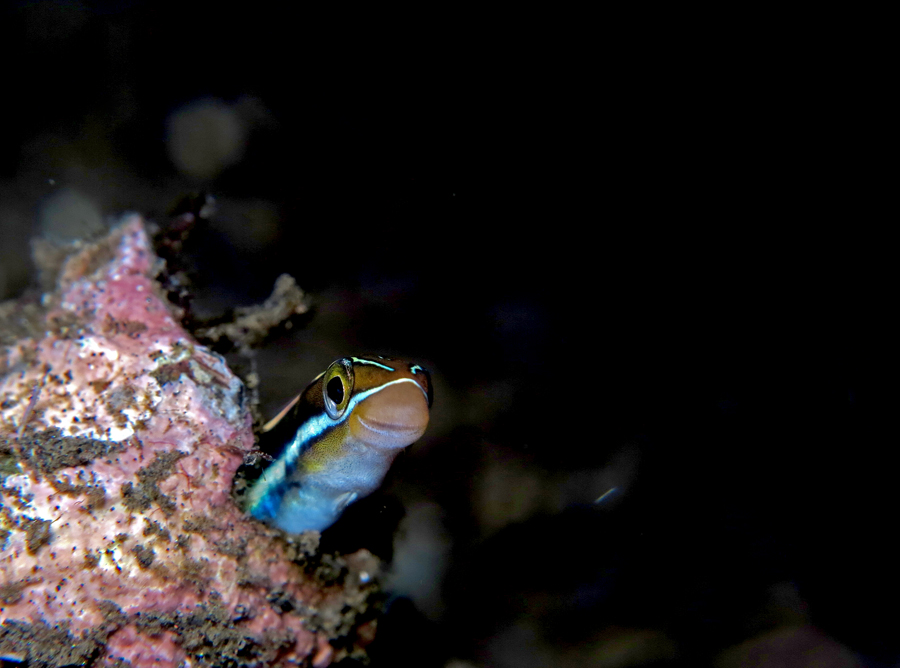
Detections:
[247, 355, 434, 533]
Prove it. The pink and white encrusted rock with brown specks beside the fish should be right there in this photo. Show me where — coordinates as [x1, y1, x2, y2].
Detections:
[0, 216, 378, 667]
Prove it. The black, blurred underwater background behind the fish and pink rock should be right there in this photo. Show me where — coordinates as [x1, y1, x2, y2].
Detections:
[0, 0, 888, 668]
